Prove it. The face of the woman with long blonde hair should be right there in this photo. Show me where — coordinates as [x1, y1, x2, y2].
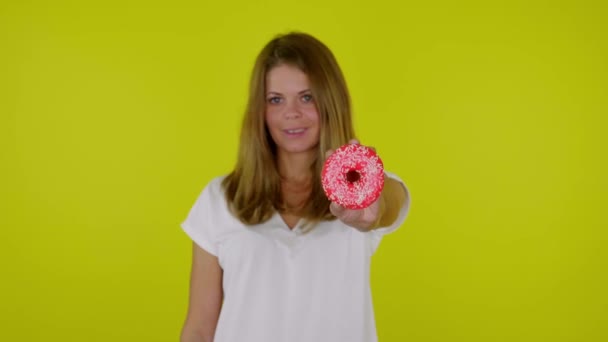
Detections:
[266, 64, 319, 153]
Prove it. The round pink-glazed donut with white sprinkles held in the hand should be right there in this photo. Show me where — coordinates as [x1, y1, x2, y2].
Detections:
[321, 144, 384, 209]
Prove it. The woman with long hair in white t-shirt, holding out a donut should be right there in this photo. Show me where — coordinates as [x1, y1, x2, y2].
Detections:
[181, 33, 409, 342]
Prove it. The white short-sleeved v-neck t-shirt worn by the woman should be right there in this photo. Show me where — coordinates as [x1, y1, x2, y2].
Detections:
[181, 172, 410, 342]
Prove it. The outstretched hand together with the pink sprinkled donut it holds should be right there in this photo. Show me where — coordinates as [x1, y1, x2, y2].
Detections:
[322, 139, 384, 231]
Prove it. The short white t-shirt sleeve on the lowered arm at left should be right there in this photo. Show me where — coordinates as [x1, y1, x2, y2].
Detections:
[181, 178, 222, 256]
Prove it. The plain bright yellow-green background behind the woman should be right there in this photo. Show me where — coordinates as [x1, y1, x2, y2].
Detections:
[0, 0, 608, 342]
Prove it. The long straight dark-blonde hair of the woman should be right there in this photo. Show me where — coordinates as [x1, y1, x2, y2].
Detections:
[222, 32, 355, 230]
